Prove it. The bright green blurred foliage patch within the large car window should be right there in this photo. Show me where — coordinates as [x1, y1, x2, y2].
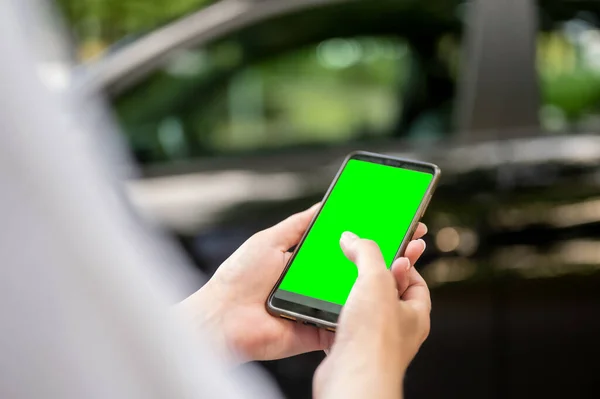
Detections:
[181, 38, 410, 152]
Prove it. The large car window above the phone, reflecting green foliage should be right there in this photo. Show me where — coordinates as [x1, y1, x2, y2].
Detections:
[108, 1, 460, 164]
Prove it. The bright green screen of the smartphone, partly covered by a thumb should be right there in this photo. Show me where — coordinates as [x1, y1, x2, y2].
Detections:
[279, 159, 433, 305]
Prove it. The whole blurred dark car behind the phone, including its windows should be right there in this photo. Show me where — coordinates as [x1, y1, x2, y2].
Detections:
[77, 0, 600, 398]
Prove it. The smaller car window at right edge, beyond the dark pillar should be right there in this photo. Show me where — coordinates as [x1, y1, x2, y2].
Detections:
[537, 2, 600, 133]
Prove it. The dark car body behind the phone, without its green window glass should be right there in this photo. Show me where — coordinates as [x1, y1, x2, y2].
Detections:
[85, 0, 600, 398]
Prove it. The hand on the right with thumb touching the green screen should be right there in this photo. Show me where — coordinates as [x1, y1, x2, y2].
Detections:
[314, 232, 431, 398]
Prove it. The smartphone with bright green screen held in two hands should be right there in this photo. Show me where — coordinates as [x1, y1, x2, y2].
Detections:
[267, 152, 440, 331]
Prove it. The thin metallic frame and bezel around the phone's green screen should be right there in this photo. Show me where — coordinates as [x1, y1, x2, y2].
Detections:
[266, 151, 441, 331]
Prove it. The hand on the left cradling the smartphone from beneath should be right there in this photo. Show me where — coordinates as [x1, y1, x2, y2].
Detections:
[181, 204, 333, 361]
